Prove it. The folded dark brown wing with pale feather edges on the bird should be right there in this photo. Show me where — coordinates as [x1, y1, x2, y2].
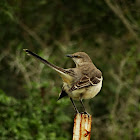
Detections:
[70, 75, 102, 91]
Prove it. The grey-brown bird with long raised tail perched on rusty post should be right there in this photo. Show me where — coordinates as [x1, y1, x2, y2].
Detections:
[24, 49, 103, 113]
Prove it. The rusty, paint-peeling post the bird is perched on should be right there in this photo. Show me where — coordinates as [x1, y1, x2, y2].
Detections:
[73, 113, 92, 140]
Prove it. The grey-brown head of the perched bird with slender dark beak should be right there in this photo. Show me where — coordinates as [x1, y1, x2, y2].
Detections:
[66, 52, 92, 67]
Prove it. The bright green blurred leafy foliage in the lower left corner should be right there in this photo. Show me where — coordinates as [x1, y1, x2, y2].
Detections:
[0, 91, 72, 140]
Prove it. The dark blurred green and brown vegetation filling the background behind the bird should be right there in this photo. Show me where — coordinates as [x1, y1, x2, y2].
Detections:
[0, 0, 140, 140]
